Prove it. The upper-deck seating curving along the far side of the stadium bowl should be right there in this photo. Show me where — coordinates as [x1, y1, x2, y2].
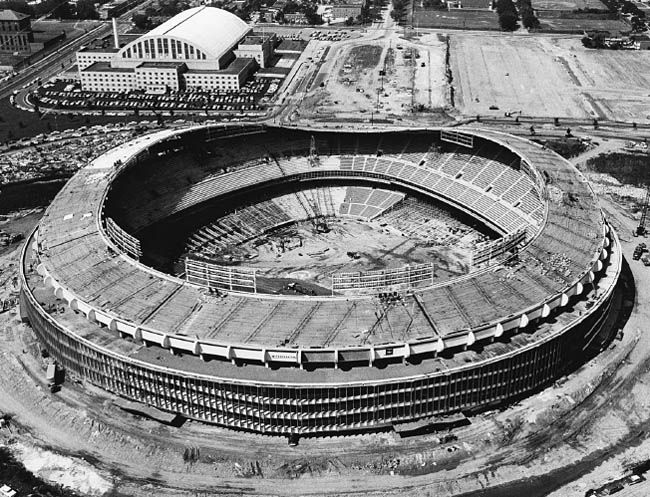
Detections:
[108, 136, 544, 239]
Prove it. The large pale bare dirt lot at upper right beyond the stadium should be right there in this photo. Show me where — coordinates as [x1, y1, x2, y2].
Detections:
[450, 35, 650, 121]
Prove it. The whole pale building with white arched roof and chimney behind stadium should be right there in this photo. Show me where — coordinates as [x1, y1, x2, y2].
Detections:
[77, 6, 276, 93]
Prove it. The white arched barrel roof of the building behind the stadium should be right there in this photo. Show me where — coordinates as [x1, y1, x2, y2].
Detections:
[129, 6, 251, 58]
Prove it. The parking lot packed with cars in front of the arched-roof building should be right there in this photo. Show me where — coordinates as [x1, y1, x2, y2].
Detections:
[31, 78, 281, 113]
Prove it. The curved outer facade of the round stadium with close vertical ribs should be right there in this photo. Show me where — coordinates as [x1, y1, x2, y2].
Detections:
[21, 231, 622, 435]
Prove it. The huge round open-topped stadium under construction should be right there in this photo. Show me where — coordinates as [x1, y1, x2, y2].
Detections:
[21, 126, 622, 435]
